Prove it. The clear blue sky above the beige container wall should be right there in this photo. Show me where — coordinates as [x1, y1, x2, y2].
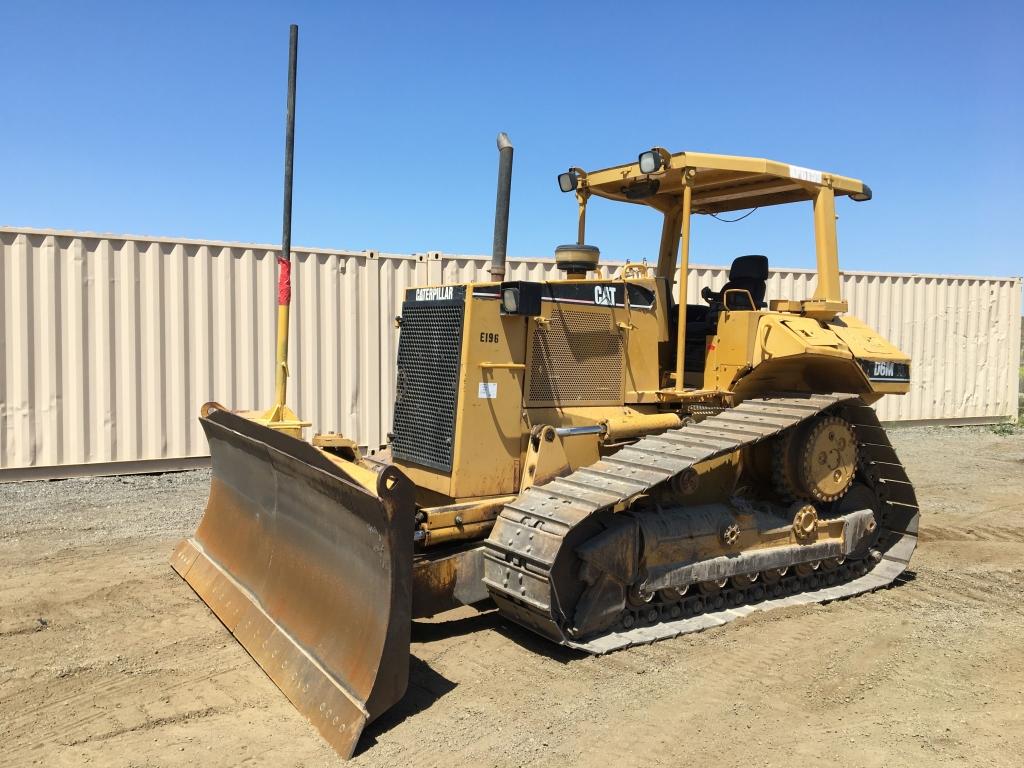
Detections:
[0, 0, 1024, 274]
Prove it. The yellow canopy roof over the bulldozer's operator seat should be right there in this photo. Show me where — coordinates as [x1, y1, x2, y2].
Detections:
[580, 151, 871, 213]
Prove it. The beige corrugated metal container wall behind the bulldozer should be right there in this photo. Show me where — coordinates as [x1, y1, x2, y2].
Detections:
[0, 228, 1021, 479]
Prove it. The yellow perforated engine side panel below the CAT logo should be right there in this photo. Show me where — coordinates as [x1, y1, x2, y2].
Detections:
[527, 307, 623, 406]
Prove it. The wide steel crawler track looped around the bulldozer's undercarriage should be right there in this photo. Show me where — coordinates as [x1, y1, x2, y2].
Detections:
[483, 394, 919, 653]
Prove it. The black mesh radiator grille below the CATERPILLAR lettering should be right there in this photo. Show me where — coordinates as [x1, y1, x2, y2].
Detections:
[391, 301, 465, 472]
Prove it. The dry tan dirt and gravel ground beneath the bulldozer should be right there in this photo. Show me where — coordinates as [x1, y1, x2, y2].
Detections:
[0, 428, 1024, 767]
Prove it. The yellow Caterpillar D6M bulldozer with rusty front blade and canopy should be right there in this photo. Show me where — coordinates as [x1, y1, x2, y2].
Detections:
[171, 33, 920, 758]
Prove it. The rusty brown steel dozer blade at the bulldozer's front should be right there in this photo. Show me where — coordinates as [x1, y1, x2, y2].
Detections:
[171, 409, 414, 758]
